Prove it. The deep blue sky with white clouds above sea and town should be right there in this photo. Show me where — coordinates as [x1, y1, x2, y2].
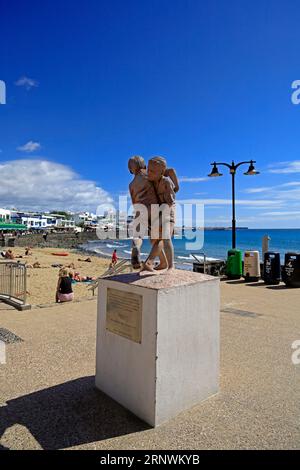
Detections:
[0, 0, 300, 228]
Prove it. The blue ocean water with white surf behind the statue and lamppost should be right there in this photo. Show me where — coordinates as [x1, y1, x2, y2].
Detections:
[81, 229, 300, 267]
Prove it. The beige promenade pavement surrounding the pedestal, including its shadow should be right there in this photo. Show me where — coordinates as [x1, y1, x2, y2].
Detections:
[0, 281, 300, 449]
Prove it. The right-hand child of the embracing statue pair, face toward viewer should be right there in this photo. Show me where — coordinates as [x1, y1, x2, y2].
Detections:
[142, 157, 179, 272]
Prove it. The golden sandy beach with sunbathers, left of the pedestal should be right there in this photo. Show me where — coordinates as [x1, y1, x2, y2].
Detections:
[13, 247, 110, 306]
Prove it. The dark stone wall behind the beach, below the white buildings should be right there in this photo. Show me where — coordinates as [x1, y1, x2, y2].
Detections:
[5, 232, 98, 248]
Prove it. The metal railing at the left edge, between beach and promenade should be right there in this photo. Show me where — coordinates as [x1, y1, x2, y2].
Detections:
[0, 261, 27, 305]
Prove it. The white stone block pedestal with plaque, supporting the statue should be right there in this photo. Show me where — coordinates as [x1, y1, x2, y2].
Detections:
[96, 270, 220, 426]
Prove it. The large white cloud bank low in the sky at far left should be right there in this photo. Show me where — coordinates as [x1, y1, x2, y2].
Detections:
[0, 160, 112, 212]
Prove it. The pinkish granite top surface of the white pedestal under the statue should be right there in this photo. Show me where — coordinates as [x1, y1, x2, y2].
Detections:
[104, 269, 218, 290]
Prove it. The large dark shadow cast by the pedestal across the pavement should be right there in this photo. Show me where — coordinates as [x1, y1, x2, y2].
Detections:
[0, 376, 150, 450]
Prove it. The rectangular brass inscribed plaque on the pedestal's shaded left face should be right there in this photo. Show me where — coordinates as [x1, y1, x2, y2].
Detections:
[106, 287, 143, 343]
